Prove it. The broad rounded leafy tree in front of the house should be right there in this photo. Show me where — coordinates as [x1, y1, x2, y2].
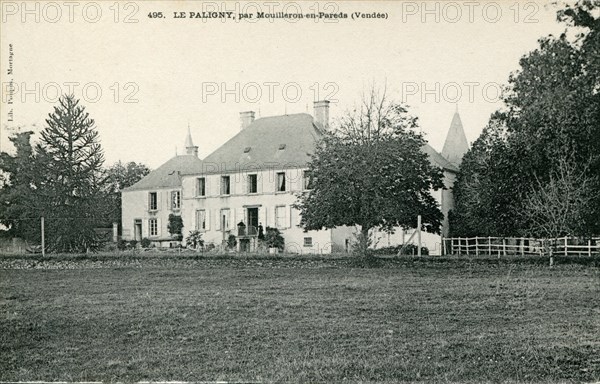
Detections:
[296, 88, 443, 254]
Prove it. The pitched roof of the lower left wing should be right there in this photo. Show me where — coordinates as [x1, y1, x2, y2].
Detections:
[123, 155, 202, 191]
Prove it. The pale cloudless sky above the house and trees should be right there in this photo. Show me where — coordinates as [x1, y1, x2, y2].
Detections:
[0, 0, 565, 168]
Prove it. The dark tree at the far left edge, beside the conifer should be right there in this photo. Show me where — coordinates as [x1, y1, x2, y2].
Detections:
[0, 131, 40, 242]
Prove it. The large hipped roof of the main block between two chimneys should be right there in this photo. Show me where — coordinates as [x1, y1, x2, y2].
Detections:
[188, 113, 322, 174]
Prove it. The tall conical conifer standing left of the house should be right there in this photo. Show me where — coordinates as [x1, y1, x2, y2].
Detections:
[35, 95, 104, 252]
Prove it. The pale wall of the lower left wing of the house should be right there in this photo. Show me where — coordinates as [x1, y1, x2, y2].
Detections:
[121, 188, 181, 245]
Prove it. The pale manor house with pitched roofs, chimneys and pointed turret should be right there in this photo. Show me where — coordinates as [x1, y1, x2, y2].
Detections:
[122, 101, 468, 254]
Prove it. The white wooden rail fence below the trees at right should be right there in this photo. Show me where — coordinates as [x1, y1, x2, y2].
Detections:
[442, 237, 600, 257]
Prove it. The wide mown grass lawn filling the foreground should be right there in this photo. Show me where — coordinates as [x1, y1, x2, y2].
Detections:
[0, 257, 600, 382]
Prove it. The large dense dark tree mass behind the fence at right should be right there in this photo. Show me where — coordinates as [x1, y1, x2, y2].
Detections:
[451, 1, 600, 236]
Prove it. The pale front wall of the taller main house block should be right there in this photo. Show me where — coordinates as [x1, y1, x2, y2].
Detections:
[182, 168, 331, 253]
